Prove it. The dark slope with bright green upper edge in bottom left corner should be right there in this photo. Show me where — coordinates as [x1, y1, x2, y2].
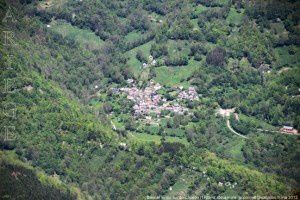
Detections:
[0, 151, 84, 199]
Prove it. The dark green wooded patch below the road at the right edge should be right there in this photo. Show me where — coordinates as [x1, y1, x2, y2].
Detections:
[242, 134, 300, 182]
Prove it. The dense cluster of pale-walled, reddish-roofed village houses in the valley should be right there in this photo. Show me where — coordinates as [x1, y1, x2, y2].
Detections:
[120, 79, 198, 116]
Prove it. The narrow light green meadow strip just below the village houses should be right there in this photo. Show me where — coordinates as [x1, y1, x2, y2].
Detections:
[128, 133, 189, 145]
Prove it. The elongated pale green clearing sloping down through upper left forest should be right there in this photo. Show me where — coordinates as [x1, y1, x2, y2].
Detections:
[50, 21, 104, 50]
